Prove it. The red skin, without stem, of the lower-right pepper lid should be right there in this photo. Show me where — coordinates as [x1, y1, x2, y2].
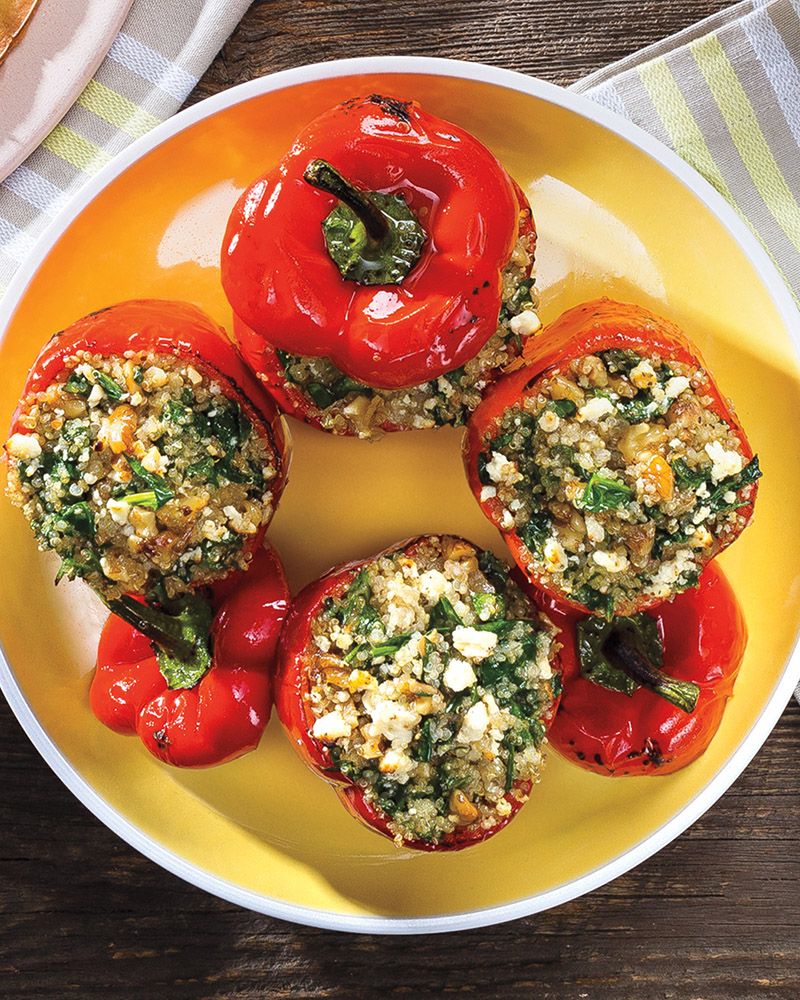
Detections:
[538, 562, 747, 776]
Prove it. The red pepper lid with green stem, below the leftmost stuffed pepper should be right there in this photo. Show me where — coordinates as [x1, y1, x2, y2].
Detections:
[89, 546, 290, 767]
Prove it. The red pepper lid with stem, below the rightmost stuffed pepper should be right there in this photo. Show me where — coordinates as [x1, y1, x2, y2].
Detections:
[542, 562, 747, 775]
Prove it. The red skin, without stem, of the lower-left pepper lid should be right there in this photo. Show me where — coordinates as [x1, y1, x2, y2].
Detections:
[89, 545, 290, 768]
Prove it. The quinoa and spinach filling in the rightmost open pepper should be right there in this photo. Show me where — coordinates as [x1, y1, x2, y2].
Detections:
[478, 350, 760, 616]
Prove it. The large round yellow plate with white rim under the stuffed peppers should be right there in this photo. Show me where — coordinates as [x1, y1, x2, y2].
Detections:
[0, 58, 800, 933]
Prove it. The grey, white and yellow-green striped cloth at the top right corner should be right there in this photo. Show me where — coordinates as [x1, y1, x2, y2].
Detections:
[573, 0, 800, 303]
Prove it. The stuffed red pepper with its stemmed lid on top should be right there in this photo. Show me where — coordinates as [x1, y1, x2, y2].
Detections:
[222, 94, 539, 437]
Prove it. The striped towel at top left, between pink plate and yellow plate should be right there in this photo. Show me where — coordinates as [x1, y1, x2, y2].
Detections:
[0, 0, 250, 296]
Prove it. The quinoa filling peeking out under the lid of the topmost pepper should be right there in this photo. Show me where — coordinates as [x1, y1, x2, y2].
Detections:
[275, 225, 540, 439]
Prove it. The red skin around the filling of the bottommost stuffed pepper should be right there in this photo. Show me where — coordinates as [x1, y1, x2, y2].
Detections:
[275, 538, 531, 851]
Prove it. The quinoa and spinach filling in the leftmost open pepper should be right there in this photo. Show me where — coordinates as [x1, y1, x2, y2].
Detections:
[6, 352, 278, 599]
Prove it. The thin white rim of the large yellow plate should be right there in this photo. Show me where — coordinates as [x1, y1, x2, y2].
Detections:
[0, 56, 800, 934]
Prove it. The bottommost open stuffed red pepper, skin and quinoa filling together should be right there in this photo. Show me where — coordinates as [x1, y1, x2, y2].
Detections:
[276, 536, 560, 850]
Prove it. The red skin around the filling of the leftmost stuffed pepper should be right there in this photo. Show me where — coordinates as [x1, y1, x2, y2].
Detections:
[4, 299, 290, 584]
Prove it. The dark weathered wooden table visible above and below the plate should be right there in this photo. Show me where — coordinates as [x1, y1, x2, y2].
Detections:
[0, 0, 800, 1000]
